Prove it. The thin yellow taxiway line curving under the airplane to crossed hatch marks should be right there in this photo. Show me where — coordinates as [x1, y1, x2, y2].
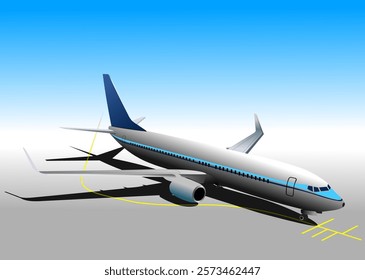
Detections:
[80, 119, 362, 241]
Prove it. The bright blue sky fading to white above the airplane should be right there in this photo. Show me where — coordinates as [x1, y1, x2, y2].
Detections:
[0, 1, 365, 127]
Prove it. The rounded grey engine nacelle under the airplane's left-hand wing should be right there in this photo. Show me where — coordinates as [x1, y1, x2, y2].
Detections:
[169, 177, 206, 203]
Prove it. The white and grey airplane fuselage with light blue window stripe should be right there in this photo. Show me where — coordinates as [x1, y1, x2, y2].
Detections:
[110, 127, 344, 212]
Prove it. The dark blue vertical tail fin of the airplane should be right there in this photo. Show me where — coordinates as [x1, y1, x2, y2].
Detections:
[103, 74, 145, 131]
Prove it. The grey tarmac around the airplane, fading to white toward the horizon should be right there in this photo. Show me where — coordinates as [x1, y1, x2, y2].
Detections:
[0, 128, 365, 260]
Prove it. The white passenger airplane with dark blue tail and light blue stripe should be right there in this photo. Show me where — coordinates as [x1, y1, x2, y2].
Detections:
[7, 74, 345, 221]
